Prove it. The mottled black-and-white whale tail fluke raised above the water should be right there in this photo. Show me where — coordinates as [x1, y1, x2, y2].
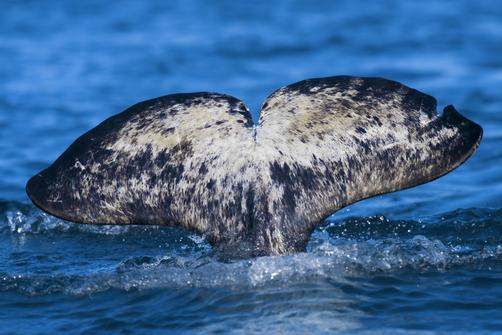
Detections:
[27, 76, 482, 256]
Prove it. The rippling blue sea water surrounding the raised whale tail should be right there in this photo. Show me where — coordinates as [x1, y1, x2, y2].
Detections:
[0, 0, 502, 334]
